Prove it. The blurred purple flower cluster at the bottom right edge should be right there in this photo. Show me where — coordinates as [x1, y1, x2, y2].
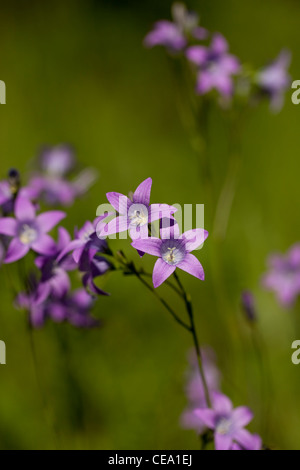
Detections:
[181, 349, 262, 450]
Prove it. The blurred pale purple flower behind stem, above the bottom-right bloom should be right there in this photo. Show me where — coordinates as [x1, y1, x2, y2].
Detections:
[180, 347, 220, 434]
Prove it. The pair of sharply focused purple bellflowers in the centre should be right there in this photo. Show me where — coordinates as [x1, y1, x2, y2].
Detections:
[99, 178, 208, 288]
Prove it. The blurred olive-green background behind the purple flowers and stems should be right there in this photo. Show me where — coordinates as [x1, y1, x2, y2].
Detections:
[0, 0, 300, 449]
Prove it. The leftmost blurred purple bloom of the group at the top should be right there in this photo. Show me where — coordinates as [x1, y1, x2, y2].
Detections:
[144, 3, 207, 52]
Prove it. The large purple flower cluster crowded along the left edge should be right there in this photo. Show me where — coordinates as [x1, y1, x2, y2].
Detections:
[0, 146, 108, 327]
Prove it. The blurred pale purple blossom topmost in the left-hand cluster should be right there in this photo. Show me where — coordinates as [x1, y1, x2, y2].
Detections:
[28, 145, 95, 206]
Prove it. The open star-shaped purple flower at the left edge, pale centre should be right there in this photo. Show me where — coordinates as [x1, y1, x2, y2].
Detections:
[0, 195, 65, 263]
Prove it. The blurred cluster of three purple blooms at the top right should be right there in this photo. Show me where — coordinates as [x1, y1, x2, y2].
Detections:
[144, 3, 291, 111]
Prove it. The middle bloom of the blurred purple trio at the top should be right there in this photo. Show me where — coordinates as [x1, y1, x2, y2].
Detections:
[186, 34, 240, 97]
